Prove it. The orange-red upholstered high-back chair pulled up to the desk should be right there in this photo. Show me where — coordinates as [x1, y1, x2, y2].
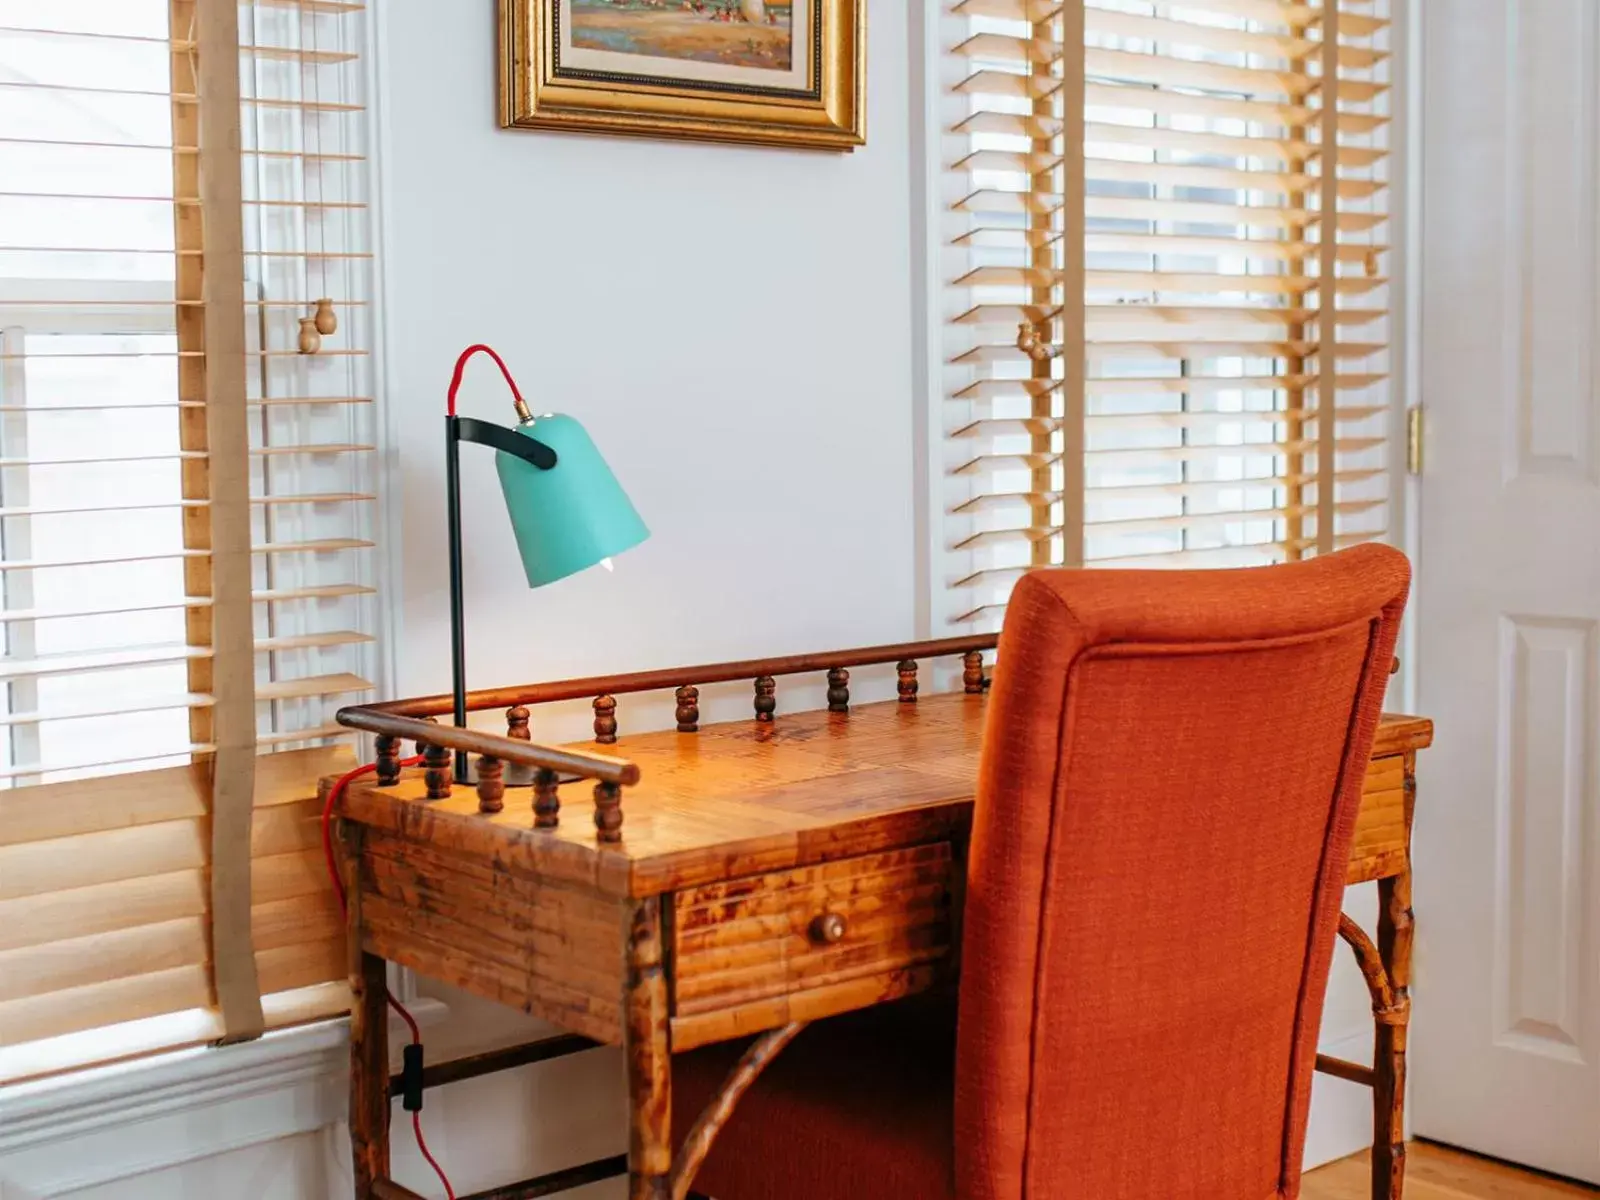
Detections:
[675, 546, 1410, 1200]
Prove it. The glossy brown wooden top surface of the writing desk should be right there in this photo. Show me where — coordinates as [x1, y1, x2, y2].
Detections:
[341, 693, 1434, 896]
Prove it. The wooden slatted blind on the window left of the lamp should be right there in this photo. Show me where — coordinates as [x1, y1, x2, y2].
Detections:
[0, 0, 376, 1080]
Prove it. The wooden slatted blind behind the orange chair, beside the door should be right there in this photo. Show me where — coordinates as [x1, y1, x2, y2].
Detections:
[944, 0, 1390, 624]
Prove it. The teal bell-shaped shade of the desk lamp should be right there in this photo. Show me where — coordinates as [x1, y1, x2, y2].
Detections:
[494, 413, 650, 587]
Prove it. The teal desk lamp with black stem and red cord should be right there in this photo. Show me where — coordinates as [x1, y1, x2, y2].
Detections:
[445, 344, 650, 784]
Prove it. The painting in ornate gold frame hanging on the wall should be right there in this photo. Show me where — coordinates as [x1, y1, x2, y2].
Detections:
[499, 0, 867, 150]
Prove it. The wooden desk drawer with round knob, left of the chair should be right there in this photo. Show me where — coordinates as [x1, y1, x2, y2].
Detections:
[672, 842, 954, 1046]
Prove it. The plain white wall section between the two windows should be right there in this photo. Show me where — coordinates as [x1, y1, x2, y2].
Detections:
[379, 3, 914, 720]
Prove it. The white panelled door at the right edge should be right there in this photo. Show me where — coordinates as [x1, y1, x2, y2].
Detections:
[1411, 0, 1600, 1182]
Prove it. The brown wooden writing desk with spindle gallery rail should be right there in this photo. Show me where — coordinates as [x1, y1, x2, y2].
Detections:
[341, 638, 1432, 1200]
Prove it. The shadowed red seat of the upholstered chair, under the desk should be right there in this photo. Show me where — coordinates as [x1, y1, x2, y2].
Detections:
[672, 995, 955, 1200]
